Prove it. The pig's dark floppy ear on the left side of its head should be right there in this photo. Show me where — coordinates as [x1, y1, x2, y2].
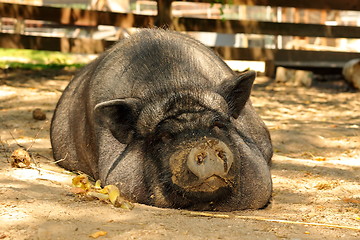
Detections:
[94, 98, 140, 144]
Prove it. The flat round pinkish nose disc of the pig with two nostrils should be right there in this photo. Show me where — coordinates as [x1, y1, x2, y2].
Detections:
[187, 138, 234, 180]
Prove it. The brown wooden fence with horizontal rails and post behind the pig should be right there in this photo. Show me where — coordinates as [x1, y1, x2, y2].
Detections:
[0, 0, 360, 75]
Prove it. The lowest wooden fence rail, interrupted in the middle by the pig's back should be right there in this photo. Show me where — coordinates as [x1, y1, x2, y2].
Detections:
[0, 33, 360, 67]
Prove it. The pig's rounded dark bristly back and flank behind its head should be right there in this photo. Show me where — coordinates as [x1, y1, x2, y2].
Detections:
[51, 29, 234, 178]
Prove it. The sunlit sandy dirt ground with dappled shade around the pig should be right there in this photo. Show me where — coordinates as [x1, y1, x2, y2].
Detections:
[0, 70, 360, 240]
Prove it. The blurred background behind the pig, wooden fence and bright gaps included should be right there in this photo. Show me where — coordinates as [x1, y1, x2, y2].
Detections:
[0, 0, 360, 77]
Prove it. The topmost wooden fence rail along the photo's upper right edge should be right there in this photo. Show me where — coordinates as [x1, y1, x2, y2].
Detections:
[179, 0, 360, 11]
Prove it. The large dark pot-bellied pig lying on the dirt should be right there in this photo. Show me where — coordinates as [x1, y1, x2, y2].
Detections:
[51, 29, 273, 211]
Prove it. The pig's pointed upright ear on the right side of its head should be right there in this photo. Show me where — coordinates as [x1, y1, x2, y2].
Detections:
[217, 71, 256, 118]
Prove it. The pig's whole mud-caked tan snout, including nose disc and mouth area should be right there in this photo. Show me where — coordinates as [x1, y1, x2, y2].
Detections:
[170, 137, 236, 192]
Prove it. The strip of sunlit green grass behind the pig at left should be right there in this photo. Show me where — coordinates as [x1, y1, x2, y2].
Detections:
[0, 48, 91, 69]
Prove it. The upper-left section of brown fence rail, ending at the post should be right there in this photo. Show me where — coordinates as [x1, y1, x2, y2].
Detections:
[0, 3, 156, 28]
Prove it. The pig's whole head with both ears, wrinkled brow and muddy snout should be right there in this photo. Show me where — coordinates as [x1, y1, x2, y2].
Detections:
[95, 71, 255, 206]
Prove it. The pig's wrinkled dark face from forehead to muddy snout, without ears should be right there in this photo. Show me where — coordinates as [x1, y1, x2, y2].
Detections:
[138, 92, 240, 201]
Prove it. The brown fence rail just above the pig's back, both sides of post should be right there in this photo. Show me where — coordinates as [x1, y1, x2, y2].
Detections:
[0, 3, 360, 38]
